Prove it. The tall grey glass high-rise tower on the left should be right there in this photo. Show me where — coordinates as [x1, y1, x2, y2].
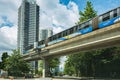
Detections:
[17, 0, 39, 54]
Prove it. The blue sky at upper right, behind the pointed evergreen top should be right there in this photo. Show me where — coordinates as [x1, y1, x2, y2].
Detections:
[59, 0, 120, 15]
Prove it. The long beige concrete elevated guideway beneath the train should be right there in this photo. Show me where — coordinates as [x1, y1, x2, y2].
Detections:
[23, 22, 120, 61]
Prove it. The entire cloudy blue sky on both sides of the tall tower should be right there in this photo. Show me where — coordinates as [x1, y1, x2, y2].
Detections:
[0, 0, 120, 61]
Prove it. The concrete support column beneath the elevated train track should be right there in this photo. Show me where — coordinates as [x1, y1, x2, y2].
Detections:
[43, 59, 50, 78]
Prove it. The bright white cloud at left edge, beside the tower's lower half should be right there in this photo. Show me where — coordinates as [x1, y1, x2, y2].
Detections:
[0, 26, 17, 51]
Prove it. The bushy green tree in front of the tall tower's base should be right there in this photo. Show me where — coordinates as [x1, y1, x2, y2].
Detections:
[5, 50, 30, 77]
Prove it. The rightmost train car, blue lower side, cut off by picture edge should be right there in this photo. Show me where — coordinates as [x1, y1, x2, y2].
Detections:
[98, 7, 120, 28]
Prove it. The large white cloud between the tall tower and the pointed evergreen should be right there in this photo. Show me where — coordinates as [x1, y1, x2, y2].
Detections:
[37, 0, 79, 33]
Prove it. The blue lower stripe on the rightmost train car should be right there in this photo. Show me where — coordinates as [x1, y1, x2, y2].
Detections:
[98, 16, 120, 28]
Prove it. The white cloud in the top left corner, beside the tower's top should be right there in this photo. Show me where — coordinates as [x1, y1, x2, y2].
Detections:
[0, 0, 21, 25]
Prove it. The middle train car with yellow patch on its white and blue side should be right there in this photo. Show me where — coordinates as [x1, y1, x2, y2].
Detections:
[48, 19, 93, 45]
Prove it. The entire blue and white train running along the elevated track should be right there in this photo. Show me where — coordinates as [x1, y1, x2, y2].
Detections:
[23, 7, 120, 53]
